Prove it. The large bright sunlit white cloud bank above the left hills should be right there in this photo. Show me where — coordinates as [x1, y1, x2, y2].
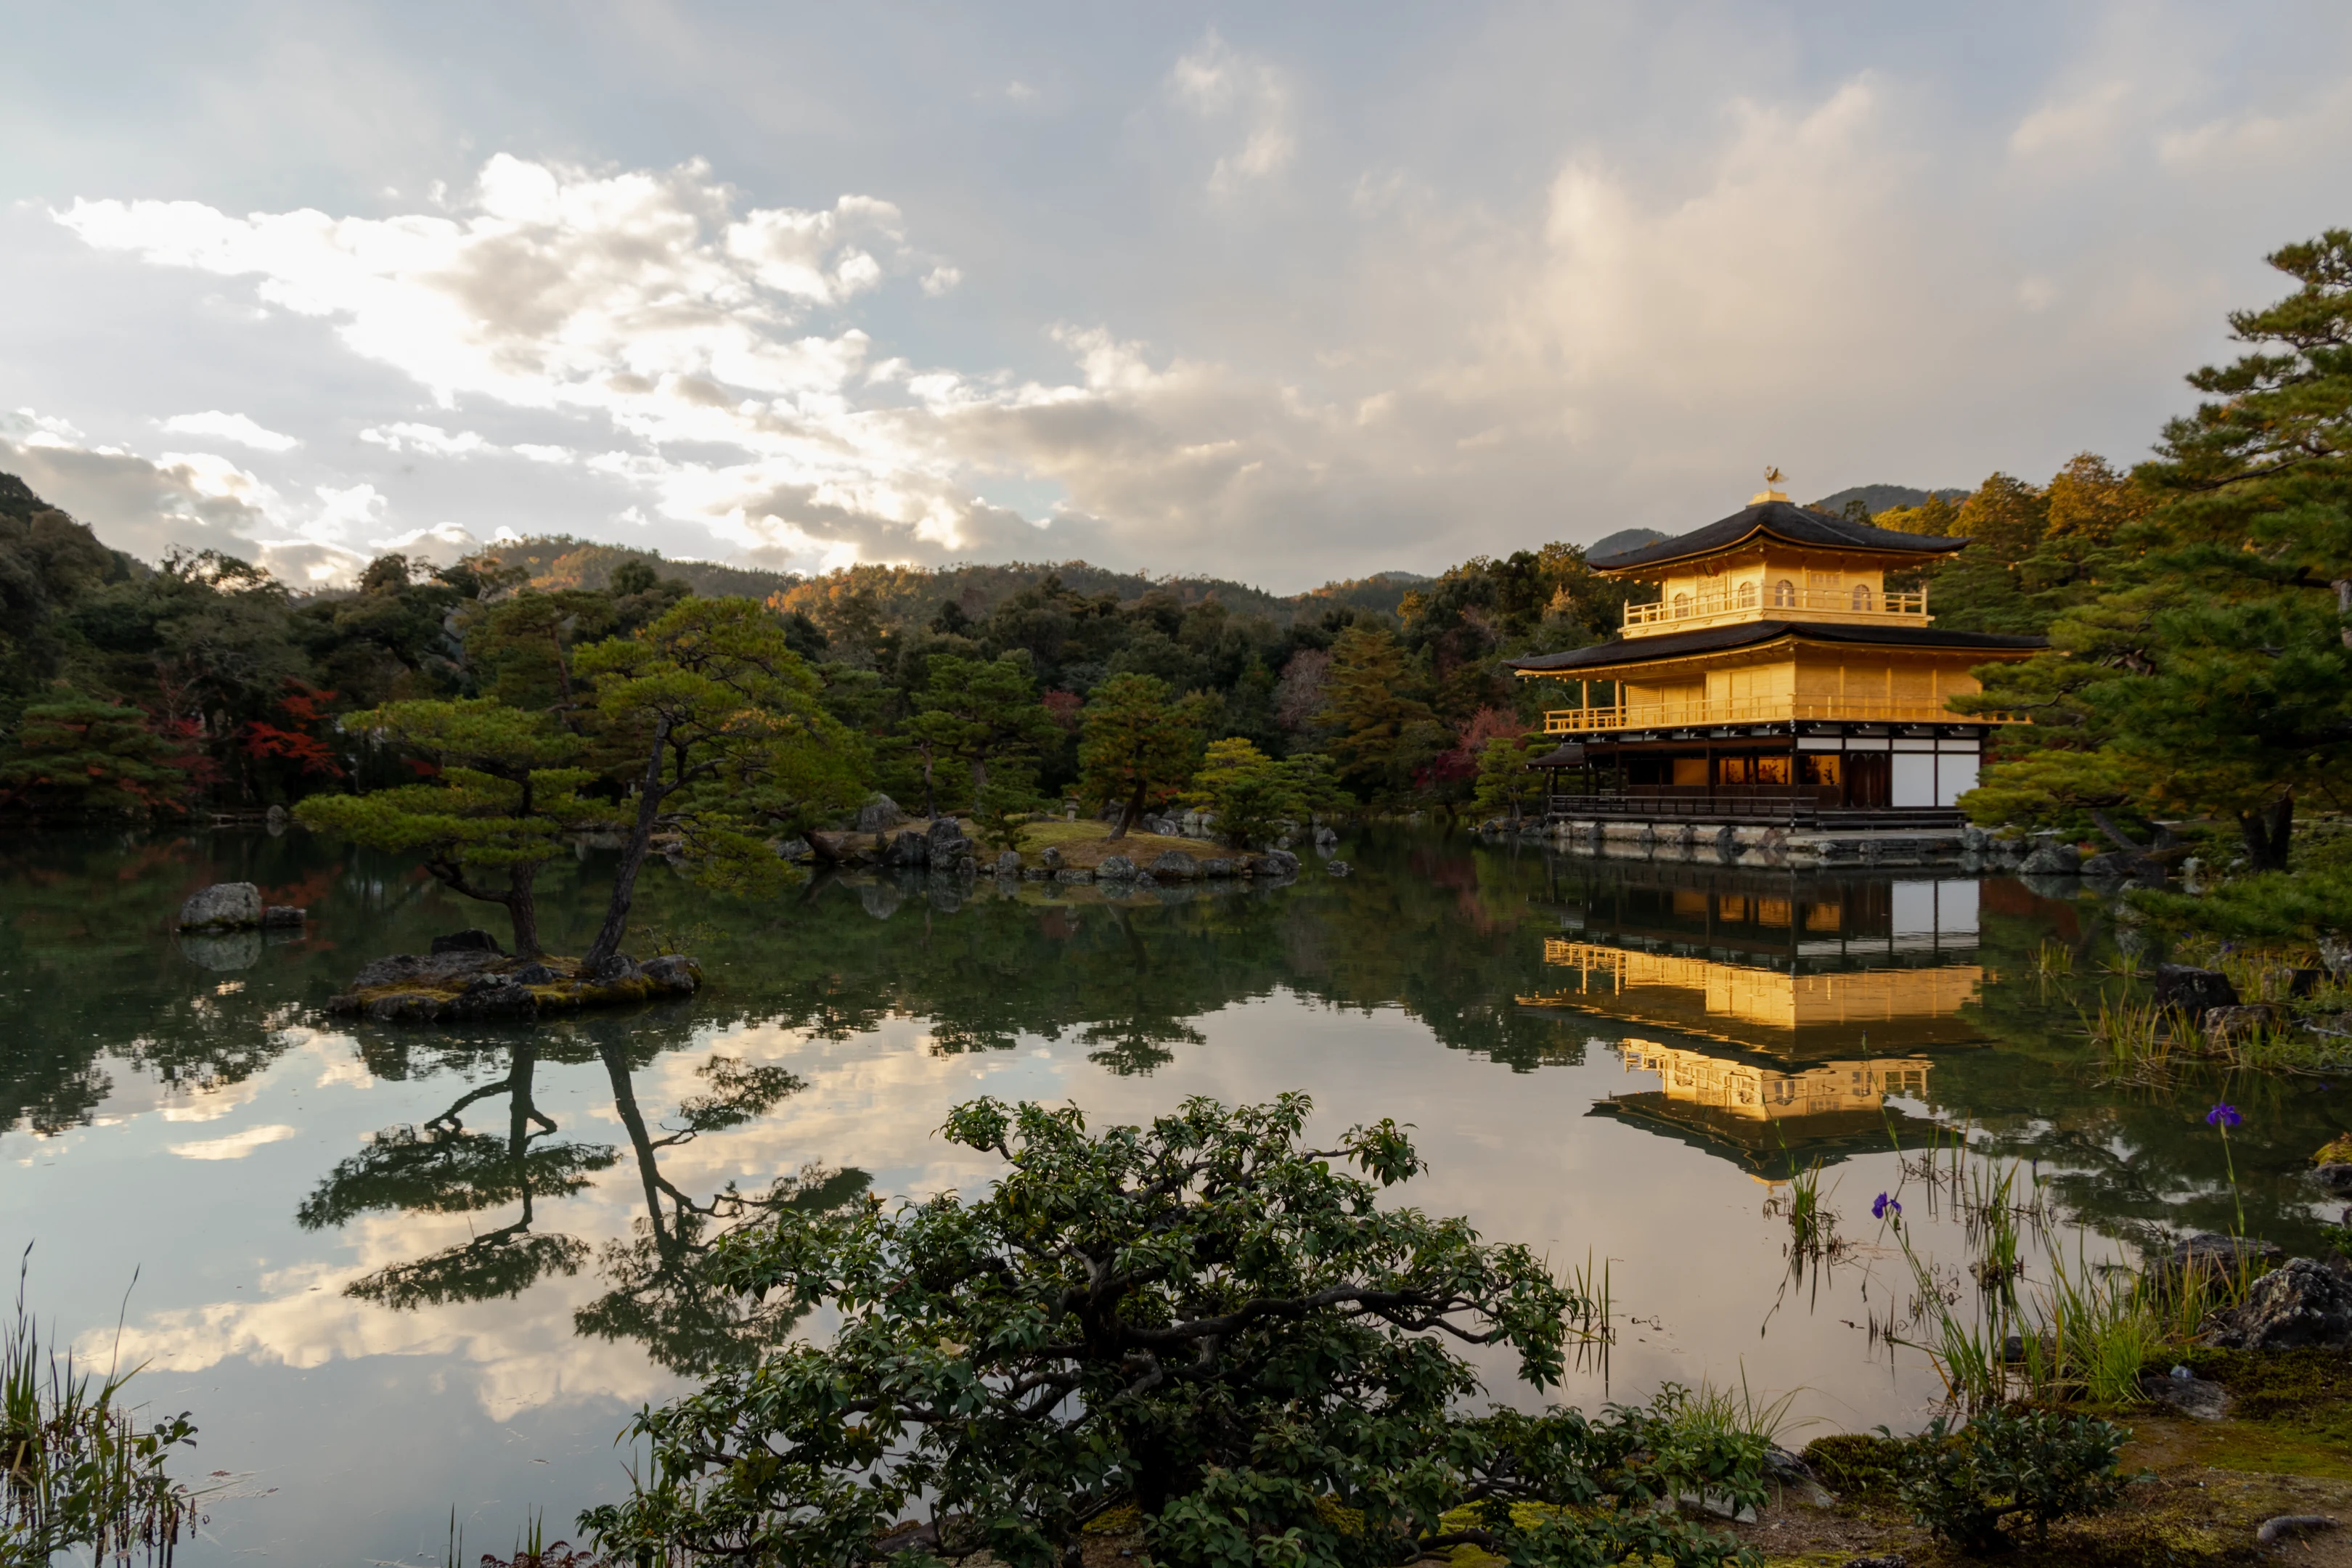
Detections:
[57, 152, 1049, 576]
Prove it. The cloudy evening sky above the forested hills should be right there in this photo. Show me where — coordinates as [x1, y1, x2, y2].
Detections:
[0, 0, 2352, 592]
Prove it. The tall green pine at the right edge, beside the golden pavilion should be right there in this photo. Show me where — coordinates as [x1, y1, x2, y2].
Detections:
[1957, 230, 2352, 870]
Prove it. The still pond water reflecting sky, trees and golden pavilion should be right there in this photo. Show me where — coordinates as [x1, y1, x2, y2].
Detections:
[0, 832, 2352, 1566]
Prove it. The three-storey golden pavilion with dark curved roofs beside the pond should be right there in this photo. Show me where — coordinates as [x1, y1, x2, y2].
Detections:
[1510, 473, 2046, 828]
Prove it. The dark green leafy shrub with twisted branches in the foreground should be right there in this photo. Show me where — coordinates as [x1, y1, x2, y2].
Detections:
[581, 1095, 1764, 1568]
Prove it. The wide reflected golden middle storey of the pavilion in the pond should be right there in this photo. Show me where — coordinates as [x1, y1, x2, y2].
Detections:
[1519, 938, 1985, 1055]
